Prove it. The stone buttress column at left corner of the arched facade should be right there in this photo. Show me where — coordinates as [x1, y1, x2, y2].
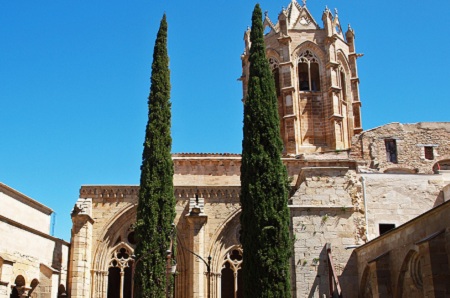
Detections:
[69, 198, 94, 298]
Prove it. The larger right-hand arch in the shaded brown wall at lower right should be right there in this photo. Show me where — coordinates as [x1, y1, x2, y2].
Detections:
[394, 248, 423, 298]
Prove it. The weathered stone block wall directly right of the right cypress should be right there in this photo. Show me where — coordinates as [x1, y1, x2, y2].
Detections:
[289, 166, 365, 297]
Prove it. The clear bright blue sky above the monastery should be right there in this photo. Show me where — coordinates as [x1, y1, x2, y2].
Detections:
[0, 0, 450, 240]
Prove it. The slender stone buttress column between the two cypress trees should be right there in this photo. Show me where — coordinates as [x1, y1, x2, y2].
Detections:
[186, 197, 207, 298]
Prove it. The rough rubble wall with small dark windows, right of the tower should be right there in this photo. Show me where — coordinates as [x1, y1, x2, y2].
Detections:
[351, 122, 450, 174]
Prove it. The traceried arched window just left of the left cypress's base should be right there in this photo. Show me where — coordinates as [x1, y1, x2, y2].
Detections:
[108, 247, 133, 298]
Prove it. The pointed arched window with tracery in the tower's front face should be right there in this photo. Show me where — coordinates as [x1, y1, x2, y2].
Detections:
[298, 50, 320, 92]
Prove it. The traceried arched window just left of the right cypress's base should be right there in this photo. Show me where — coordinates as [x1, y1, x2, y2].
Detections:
[221, 248, 244, 298]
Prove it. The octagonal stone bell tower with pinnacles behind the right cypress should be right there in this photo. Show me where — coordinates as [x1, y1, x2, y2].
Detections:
[241, 0, 362, 155]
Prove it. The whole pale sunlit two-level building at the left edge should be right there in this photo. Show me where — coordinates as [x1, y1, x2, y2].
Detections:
[0, 183, 69, 298]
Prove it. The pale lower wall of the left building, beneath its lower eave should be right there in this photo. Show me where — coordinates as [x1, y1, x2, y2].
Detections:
[0, 216, 69, 298]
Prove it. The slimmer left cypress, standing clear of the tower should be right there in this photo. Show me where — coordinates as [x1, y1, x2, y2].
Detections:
[134, 14, 175, 297]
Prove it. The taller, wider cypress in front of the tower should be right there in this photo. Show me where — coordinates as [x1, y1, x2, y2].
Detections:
[241, 4, 291, 298]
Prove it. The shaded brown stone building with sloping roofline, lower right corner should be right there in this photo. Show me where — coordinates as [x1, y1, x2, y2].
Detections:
[355, 201, 450, 298]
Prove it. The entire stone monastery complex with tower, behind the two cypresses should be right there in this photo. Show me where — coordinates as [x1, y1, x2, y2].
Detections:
[0, 0, 450, 298]
